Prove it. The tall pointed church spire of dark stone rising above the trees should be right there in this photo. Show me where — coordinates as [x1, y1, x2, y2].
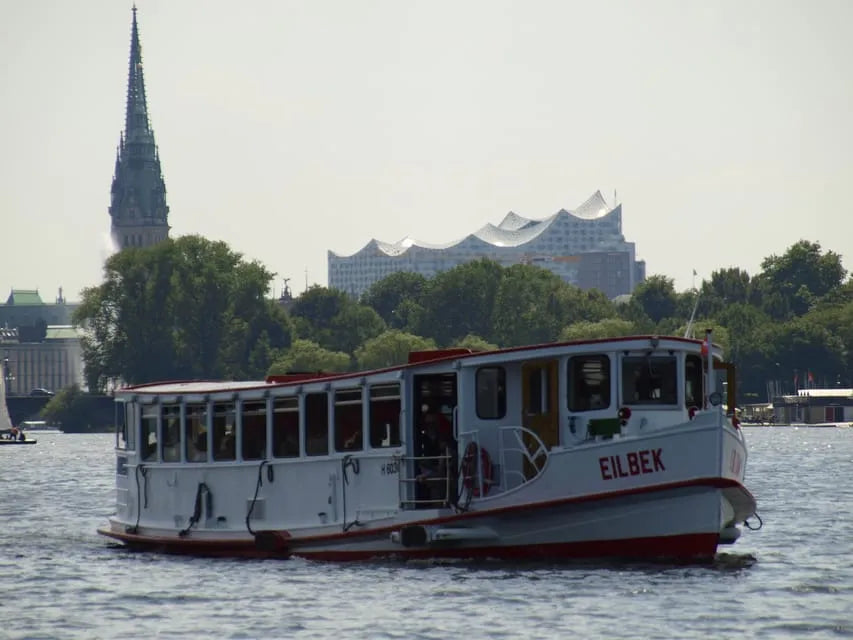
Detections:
[110, 5, 169, 249]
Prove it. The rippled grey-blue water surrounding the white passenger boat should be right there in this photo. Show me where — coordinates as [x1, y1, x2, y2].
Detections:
[0, 427, 853, 640]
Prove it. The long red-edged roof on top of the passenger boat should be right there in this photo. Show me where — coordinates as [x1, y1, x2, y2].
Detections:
[115, 335, 720, 399]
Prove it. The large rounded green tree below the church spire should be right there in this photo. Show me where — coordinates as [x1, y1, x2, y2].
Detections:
[74, 236, 291, 390]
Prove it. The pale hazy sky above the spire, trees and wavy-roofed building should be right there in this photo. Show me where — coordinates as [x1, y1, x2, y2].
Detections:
[0, 0, 853, 301]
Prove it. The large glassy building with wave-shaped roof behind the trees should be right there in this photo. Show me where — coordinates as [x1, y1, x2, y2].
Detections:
[328, 191, 646, 298]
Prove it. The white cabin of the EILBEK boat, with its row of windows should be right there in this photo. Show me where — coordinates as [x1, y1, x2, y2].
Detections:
[110, 336, 734, 530]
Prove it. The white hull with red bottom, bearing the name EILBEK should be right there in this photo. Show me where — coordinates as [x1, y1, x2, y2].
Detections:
[101, 424, 755, 561]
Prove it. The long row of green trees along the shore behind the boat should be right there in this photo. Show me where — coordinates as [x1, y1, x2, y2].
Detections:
[74, 236, 853, 402]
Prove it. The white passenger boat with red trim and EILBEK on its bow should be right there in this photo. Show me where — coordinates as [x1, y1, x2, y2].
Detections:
[98, 334, 757, 562]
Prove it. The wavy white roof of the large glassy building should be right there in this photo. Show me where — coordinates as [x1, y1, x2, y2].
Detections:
[329, 191, 615, 258]
